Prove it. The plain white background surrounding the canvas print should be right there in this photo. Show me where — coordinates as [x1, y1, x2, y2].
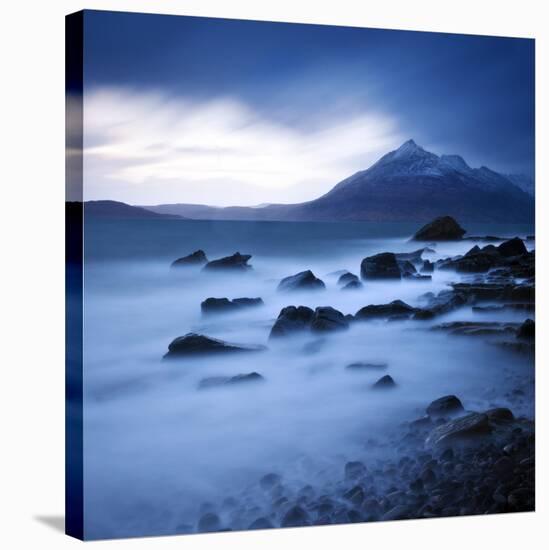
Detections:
[0, 0, 549, 550]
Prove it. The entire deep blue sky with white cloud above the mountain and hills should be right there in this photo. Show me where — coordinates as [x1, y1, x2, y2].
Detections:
[76, 11, 534, 206]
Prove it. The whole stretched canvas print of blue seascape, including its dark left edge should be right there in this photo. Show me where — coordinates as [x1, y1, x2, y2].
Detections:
[66, 11, 535, 539]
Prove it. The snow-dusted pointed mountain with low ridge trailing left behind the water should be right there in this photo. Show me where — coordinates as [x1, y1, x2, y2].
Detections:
[146, 140, 534, 223]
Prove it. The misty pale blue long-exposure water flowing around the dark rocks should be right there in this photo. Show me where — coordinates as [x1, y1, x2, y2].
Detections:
[84, 220, 533, 538]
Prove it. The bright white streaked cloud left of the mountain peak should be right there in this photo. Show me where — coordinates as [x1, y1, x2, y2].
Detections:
[84, 87, 402, 205]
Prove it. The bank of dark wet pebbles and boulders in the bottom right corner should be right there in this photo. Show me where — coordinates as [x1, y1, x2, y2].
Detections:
[195, 396, 535, 532]
